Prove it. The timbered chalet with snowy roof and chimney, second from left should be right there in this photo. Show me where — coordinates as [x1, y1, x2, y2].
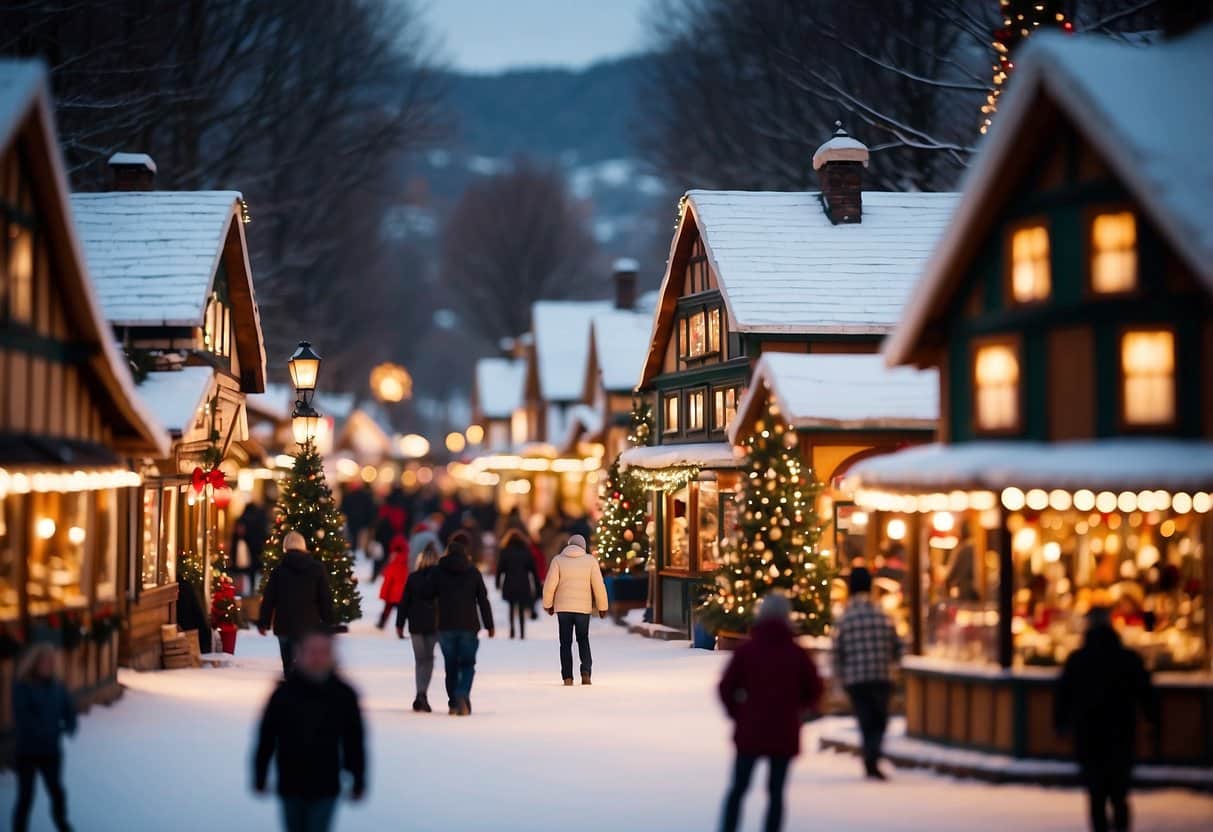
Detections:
[72, 161, 266, 669]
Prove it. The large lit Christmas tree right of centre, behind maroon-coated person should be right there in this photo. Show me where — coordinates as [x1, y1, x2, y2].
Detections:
[700, 408, 831, 636]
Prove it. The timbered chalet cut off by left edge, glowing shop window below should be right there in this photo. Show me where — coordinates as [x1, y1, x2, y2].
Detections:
[0, 61, 169, 756]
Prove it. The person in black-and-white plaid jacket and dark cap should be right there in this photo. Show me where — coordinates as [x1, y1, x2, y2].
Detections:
[833, 566, 901, 780]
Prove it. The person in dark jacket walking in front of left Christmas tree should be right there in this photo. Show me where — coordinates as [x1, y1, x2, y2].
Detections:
[257, 531, 332, 676]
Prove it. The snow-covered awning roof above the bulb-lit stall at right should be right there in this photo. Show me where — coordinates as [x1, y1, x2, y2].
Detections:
[845, 438, 1213, 491]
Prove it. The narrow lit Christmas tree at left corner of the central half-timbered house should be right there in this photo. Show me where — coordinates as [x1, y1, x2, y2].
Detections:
[593, 399, 653, 575]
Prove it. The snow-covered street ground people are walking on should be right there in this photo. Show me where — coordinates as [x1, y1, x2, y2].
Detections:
[0, 570, 1213, 832]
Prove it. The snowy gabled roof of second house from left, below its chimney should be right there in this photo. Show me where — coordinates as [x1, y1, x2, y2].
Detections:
[72, 190, 266, 392]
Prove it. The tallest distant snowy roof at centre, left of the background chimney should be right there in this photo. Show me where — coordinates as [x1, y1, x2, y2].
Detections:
[531, 301, 611, 401]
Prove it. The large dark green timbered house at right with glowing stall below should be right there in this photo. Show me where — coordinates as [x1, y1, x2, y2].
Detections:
[847, 27, 1213, 767]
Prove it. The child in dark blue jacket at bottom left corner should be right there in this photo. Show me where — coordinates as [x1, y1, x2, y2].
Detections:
[12, 644, 76, 832]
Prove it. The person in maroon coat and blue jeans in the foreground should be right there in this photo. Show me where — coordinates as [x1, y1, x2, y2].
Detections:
[719, 593, 822, 832]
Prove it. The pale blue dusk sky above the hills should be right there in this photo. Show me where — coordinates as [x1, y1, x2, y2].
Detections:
[417, 0, 650, 72]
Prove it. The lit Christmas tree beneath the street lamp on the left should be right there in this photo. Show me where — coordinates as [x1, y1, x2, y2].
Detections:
[261, 444, 363, 623]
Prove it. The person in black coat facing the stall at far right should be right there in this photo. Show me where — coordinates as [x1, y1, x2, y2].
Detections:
[1054, 608, 1158, 832]
